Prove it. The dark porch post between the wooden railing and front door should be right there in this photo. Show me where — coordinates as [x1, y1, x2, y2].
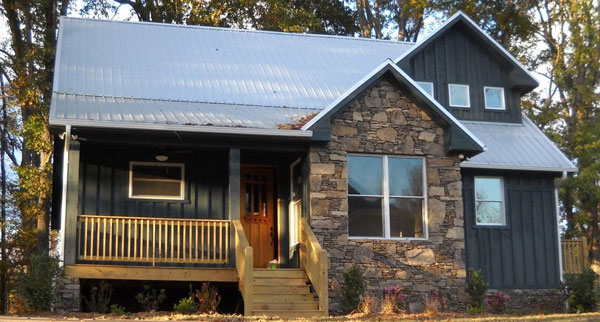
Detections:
[227, 148, 241, 264]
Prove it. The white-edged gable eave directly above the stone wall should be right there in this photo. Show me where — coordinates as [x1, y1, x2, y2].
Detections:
[302, 59, 485, 152]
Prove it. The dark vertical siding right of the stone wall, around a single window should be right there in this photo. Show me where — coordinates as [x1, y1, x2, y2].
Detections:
[462, 169, 560, 289]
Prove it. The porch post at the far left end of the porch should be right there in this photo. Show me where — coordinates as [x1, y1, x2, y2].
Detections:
[64, 140, 80, 265]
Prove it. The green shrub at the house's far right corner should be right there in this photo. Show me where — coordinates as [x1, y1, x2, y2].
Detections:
[565, 269, 597, 312]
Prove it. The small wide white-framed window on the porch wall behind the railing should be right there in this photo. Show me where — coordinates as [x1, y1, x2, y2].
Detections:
[129, 161, 185, 200]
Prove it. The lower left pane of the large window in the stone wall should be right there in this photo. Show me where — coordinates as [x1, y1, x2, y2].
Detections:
[348, 196, 383, 237]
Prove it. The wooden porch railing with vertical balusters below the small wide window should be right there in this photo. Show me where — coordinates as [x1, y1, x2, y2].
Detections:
[77, 215, 230, 265]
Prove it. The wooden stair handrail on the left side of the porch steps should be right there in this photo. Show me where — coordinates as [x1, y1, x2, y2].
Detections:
[232, 220, 254, 316]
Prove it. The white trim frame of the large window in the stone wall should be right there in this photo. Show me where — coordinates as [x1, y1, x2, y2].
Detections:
[346, 153, 429, 242]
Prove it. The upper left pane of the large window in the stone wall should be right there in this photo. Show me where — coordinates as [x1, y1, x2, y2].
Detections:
[348, 156, 383, 195]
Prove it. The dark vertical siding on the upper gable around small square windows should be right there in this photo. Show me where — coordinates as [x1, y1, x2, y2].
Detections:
[400, 25, 521, 123]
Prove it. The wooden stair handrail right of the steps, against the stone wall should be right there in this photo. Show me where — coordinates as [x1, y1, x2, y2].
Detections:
[300, 219, 329, 316]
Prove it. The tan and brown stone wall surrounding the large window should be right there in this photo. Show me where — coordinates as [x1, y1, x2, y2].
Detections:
[309, 78, 466, 313]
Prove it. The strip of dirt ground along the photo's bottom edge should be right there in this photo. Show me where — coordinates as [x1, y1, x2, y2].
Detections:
[0, 312, 600, 322]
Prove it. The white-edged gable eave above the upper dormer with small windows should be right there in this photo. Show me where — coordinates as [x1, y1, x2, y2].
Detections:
[394, 11, 539, 91]
